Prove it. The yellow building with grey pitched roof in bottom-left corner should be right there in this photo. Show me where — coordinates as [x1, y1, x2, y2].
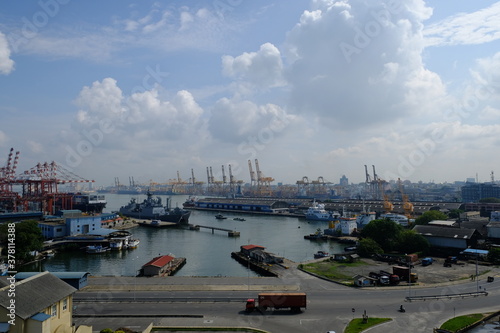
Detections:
[0, 272, 76, 333]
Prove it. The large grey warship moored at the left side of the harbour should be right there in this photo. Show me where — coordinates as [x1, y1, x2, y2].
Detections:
[119, 191, 191, 224]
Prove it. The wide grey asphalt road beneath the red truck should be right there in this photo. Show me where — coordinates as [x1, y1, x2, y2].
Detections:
[74, 268, 500, 333]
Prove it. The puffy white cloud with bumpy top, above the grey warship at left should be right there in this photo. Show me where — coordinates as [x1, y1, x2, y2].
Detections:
[76, 78, 203, 146]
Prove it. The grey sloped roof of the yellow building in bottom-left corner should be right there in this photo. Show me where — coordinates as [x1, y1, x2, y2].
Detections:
[0, 272, 76, 320]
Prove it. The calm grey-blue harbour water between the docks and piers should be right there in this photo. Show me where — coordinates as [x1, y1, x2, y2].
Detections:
[23, 194, 344, 277]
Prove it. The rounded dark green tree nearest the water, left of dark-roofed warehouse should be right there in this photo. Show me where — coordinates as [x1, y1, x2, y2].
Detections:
[361, 219, 403, 252]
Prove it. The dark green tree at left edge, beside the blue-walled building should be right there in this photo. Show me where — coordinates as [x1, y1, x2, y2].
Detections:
[0, 220, 43, 263]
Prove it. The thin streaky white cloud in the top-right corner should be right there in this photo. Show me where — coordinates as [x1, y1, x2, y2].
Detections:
[424, 2, 500, 46]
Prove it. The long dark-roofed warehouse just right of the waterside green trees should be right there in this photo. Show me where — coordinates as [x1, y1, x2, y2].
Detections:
[413, 225, 480, 249]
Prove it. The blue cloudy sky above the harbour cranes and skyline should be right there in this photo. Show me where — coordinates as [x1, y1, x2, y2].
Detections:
[0, 0, 500, 186]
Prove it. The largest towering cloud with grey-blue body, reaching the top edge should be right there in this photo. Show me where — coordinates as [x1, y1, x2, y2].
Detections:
[283, 0, 445, 129]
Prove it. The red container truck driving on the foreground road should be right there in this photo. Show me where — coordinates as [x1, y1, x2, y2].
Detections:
[246, 293, 307, 312]
